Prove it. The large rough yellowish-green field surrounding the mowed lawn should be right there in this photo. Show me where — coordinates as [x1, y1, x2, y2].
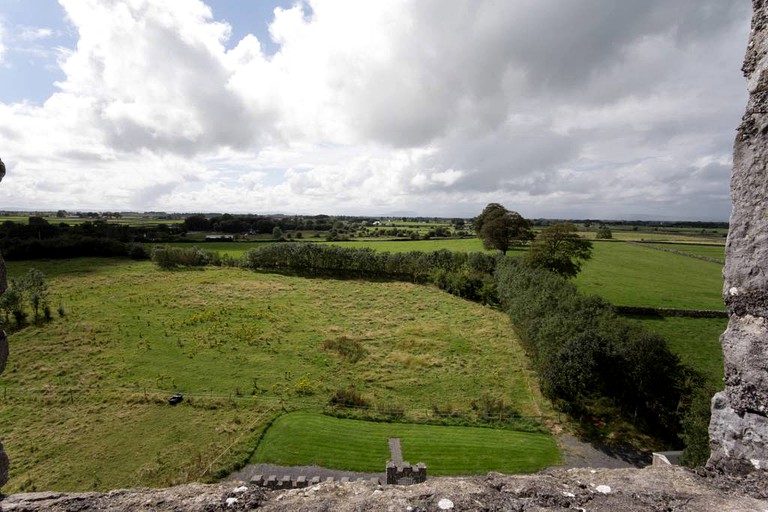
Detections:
[0, 258, 549, 492]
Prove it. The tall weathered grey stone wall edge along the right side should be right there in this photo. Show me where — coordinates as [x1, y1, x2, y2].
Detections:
[709, 0, 768, 472]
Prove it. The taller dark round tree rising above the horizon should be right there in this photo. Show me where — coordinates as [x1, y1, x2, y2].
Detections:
[475, 203, 533, 254]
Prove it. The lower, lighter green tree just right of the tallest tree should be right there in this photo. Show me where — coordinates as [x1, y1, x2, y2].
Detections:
[524, 222, 592, 277]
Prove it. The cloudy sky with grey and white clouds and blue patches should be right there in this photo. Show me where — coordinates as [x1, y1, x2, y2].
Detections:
[0, 0, 751, 220]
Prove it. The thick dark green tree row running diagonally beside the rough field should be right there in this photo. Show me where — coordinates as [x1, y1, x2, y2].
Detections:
[496, 260, 693, 441]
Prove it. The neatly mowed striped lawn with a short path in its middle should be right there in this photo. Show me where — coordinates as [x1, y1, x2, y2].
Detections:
[251, 413, 560, 475]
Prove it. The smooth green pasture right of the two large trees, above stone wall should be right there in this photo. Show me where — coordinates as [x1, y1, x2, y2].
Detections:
[574, 242, 725, 310]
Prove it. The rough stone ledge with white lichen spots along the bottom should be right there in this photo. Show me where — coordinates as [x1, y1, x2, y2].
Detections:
[0, 466, 768, 512]
